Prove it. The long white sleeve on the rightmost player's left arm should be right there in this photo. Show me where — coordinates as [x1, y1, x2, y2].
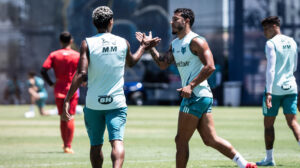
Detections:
[266, 41, 276, 93]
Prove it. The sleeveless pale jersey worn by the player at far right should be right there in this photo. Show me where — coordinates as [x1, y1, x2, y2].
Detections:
[269, 34, 298, 95]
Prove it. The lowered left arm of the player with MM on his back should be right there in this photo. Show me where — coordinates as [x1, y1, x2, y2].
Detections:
[61, 40, 89, 121]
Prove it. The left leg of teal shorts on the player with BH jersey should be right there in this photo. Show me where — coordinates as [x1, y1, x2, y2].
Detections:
[83, 107, 105, 146]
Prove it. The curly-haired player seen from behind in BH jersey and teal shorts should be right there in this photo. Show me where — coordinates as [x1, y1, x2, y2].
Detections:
[62, 6, 160, 168]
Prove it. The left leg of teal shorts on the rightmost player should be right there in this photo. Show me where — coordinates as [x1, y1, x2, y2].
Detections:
[262, 95, 282, 117]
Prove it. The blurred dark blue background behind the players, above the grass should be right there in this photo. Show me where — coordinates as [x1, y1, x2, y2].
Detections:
[0, 0, 300, 106]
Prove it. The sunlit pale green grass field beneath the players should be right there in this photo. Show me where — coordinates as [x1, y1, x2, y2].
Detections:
[0, 106, 300, 168]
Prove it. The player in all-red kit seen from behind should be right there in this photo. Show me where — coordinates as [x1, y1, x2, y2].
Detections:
[41, 32, 79, 154]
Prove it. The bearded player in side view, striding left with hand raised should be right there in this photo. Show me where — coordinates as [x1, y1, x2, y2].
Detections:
[136, 8, 256, 168]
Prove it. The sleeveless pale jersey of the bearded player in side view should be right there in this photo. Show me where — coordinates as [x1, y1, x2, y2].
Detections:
[172, 31, 213, 97]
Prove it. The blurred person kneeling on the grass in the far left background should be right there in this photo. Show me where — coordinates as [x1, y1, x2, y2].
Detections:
[24, 71, 53, 118]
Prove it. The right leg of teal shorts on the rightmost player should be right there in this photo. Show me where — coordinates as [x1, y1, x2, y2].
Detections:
[282, 94, 298, 115]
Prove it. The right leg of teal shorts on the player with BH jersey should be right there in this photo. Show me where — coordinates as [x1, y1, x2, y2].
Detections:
[105, 107, 127, 141]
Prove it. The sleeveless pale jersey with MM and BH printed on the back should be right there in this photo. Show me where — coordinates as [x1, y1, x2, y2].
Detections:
[86, 33, 128, 110]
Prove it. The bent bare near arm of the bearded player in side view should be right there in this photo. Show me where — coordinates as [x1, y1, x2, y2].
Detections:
[177, 38, 216, 98]
